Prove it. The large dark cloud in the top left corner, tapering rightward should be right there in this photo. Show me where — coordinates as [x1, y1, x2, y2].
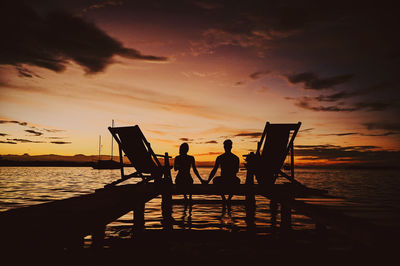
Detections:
[0, 1, 166, 77]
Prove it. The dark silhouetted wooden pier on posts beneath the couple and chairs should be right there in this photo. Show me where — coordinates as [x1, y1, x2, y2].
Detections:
[0, 183, 398, 256]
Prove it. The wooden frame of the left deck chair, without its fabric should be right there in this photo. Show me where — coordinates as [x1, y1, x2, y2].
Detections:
[105, 125, 172, 187]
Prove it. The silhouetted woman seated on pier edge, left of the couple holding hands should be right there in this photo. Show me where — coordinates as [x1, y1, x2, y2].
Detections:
[174, 143, 204, 200]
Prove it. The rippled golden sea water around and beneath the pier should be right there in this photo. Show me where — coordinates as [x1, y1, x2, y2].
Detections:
[0, 167, 400, 237]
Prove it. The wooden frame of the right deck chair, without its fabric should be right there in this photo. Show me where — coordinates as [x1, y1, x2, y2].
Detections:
[245, 122, 301, 184]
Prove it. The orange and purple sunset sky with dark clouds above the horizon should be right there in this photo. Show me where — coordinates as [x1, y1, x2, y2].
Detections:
[0, 0, 400, 166]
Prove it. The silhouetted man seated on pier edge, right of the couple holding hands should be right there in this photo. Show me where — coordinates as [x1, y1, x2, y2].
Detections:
[207, 139, 240, 202]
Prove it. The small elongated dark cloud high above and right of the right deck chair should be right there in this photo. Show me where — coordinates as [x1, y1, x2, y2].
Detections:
[286, 72, 354, 90]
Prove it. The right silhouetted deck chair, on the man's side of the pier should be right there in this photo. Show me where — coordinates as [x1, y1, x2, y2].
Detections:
[245, 122, 301, 185]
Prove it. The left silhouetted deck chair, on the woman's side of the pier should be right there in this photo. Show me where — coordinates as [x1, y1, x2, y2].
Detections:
[106, 125, 172, 186]
